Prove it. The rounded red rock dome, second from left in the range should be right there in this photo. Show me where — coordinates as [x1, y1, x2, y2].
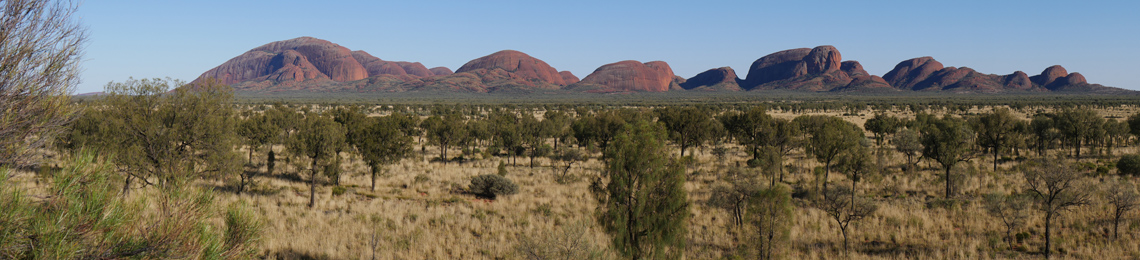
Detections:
[455, 50, 567, 86]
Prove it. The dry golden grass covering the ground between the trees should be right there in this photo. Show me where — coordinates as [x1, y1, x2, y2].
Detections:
[193, 104, 1140, 259]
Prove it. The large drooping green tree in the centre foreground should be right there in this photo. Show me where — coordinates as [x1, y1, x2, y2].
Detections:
[595, 120, 690, 259]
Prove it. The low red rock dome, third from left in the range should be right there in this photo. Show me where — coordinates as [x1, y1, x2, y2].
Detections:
[578, 60, 674, 92]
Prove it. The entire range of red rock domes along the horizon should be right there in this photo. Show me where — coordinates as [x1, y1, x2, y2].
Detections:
[196, 36, 1132, 94]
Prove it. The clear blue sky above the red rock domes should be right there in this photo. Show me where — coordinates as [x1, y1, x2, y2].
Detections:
[76, 0, 1140, 92]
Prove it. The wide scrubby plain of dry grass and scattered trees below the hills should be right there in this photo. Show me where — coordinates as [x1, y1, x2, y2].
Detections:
[13, 91, 1140, 259]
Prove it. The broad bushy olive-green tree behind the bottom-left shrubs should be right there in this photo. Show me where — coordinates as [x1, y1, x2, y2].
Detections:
[97, 79, 241, 190]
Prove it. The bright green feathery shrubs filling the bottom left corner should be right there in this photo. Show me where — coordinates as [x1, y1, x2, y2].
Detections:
[0, 154, 261, 259]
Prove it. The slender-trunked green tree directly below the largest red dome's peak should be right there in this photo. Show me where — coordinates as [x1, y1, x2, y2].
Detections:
[288, 114, 344, 208]
